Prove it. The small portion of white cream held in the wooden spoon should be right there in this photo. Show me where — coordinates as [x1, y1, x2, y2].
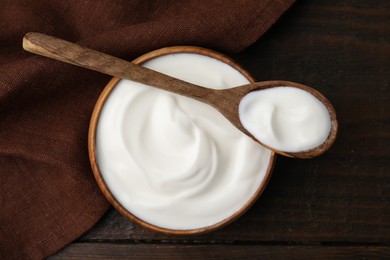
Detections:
[239, 86, 331, 152]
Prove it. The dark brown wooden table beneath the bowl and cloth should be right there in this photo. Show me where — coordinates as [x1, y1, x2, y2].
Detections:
[51, 0, 390, 259]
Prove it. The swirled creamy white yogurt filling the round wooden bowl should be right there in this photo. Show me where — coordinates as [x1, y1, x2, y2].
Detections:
[96, 54, 271, 229]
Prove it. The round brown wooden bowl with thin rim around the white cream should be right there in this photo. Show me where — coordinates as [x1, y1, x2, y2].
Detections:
[88, 46, 276, 235]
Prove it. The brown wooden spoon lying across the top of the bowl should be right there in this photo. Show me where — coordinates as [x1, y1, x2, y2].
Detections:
[23, 32, 338, 158]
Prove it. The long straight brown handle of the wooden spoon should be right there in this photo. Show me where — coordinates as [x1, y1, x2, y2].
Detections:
[23, 32, 212, 102]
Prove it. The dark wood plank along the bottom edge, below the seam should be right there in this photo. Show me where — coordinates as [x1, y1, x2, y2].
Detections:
[48, 243, 390, 260]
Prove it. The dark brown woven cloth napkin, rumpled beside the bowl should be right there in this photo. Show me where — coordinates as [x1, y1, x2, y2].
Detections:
[0, 0, 294, 259]
